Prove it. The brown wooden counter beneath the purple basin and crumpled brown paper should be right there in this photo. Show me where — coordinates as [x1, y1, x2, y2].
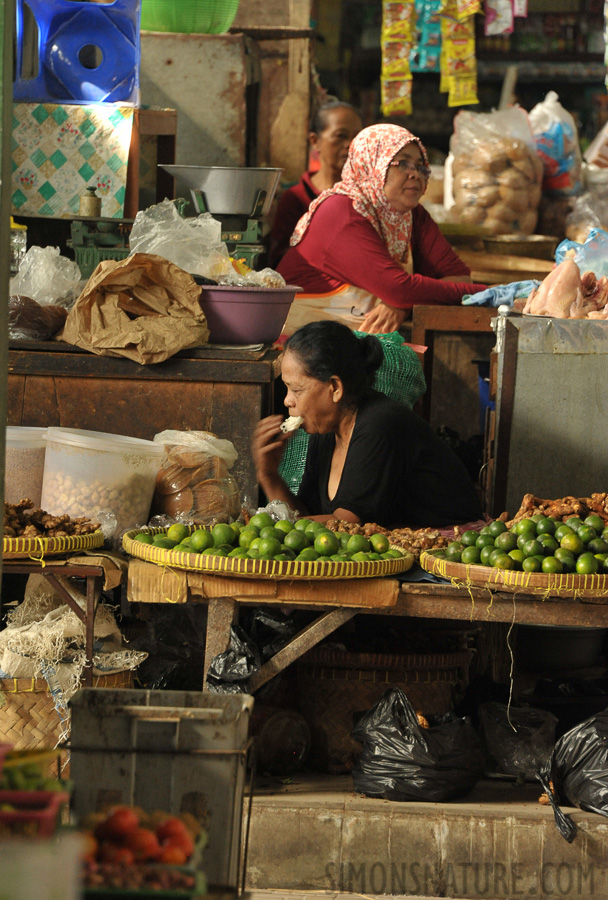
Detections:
[7, 341, 279, 505]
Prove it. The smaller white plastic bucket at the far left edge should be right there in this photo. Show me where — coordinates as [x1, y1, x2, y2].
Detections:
[4, 425, 46, 507]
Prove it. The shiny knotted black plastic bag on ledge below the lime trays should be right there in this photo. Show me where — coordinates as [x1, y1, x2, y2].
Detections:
[352, 688, 484, 802]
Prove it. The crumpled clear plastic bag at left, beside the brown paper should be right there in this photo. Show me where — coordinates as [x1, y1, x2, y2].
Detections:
[11, 247, 83, 309]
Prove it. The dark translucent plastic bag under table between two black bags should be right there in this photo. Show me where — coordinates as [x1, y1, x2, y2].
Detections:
[479, 702, 557, 781]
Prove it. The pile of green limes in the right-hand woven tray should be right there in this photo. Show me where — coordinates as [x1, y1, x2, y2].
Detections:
[433, 514, 608, 575]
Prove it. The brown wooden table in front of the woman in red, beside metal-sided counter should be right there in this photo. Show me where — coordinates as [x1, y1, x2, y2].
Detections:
[412, 306, 498, 422]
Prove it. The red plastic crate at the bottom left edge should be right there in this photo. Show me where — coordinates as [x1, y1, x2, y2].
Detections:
[0, 791, 70, 837]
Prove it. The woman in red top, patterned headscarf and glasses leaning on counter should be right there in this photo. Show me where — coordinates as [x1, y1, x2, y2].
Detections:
[278, 125, 485, 334]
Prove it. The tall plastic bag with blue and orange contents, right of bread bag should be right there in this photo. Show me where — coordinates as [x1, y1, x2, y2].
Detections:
[530, 91, 582, 197]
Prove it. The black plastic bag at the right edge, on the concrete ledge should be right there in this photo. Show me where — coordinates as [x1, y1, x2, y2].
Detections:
[540, 709, 608, 842]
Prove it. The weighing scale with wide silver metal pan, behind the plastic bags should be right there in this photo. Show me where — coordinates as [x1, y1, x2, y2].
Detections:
[162, 165, 283, 269]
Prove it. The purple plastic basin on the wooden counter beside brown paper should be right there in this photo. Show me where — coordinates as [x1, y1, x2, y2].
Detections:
[200, 284, 301, 344]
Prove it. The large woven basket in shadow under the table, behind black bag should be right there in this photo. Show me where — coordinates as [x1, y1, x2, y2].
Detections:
[298, 649, 471, 774]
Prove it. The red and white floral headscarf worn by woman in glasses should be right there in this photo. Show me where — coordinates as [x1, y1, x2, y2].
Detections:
[290, 125, 428, 263]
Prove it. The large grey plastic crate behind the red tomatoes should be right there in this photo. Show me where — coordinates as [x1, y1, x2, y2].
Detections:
[69, 688, 253, 889]
